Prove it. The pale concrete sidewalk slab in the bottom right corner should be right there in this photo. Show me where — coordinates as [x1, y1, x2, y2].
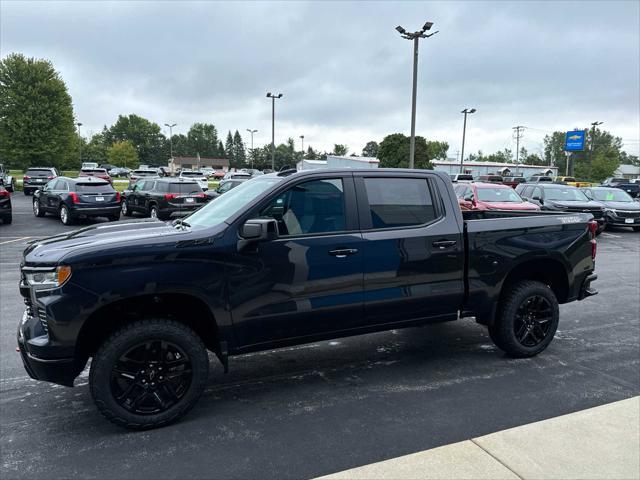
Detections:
[322, 397, 640, 480]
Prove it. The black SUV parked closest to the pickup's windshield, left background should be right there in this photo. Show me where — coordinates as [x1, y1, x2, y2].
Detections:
[122, 178, 209, 220]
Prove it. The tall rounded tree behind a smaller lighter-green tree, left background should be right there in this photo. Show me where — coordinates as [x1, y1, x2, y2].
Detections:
[103, 113, 169, 165]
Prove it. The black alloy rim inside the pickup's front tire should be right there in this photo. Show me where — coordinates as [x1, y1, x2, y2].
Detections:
[110, 340, 193, 415]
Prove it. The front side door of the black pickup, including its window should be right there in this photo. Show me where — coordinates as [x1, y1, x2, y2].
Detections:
[229, 174, 363, 347]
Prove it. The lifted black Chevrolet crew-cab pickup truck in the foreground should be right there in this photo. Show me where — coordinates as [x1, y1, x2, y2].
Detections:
[18, 169, 596, 428]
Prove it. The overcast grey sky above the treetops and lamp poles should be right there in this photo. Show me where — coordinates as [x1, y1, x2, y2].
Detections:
[0, 0, 640, 157]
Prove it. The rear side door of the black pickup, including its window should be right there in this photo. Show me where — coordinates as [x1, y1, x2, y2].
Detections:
[355, 172, 464, 325]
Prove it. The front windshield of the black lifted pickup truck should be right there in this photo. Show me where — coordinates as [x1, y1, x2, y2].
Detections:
[186, 176, 282, 228]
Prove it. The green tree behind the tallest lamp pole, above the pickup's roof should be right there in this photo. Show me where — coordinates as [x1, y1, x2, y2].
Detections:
[378, 133, 449, 169]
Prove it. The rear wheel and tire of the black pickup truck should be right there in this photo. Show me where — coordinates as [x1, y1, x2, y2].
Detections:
[489, 280, 560, 358]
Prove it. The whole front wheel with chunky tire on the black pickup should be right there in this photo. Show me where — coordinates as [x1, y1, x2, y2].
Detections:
[89, 319, 209, 430]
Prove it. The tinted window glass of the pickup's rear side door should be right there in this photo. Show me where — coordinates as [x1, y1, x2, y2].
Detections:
[364, 178, 436, 228]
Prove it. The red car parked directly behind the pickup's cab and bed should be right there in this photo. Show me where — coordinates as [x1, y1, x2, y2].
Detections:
[455, 183, 540, 210]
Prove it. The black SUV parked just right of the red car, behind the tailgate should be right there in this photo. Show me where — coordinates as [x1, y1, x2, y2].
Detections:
[516, 183, 604, 233]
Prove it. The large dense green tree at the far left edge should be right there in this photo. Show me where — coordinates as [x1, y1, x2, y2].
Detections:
[0, 53, 79, 169]
